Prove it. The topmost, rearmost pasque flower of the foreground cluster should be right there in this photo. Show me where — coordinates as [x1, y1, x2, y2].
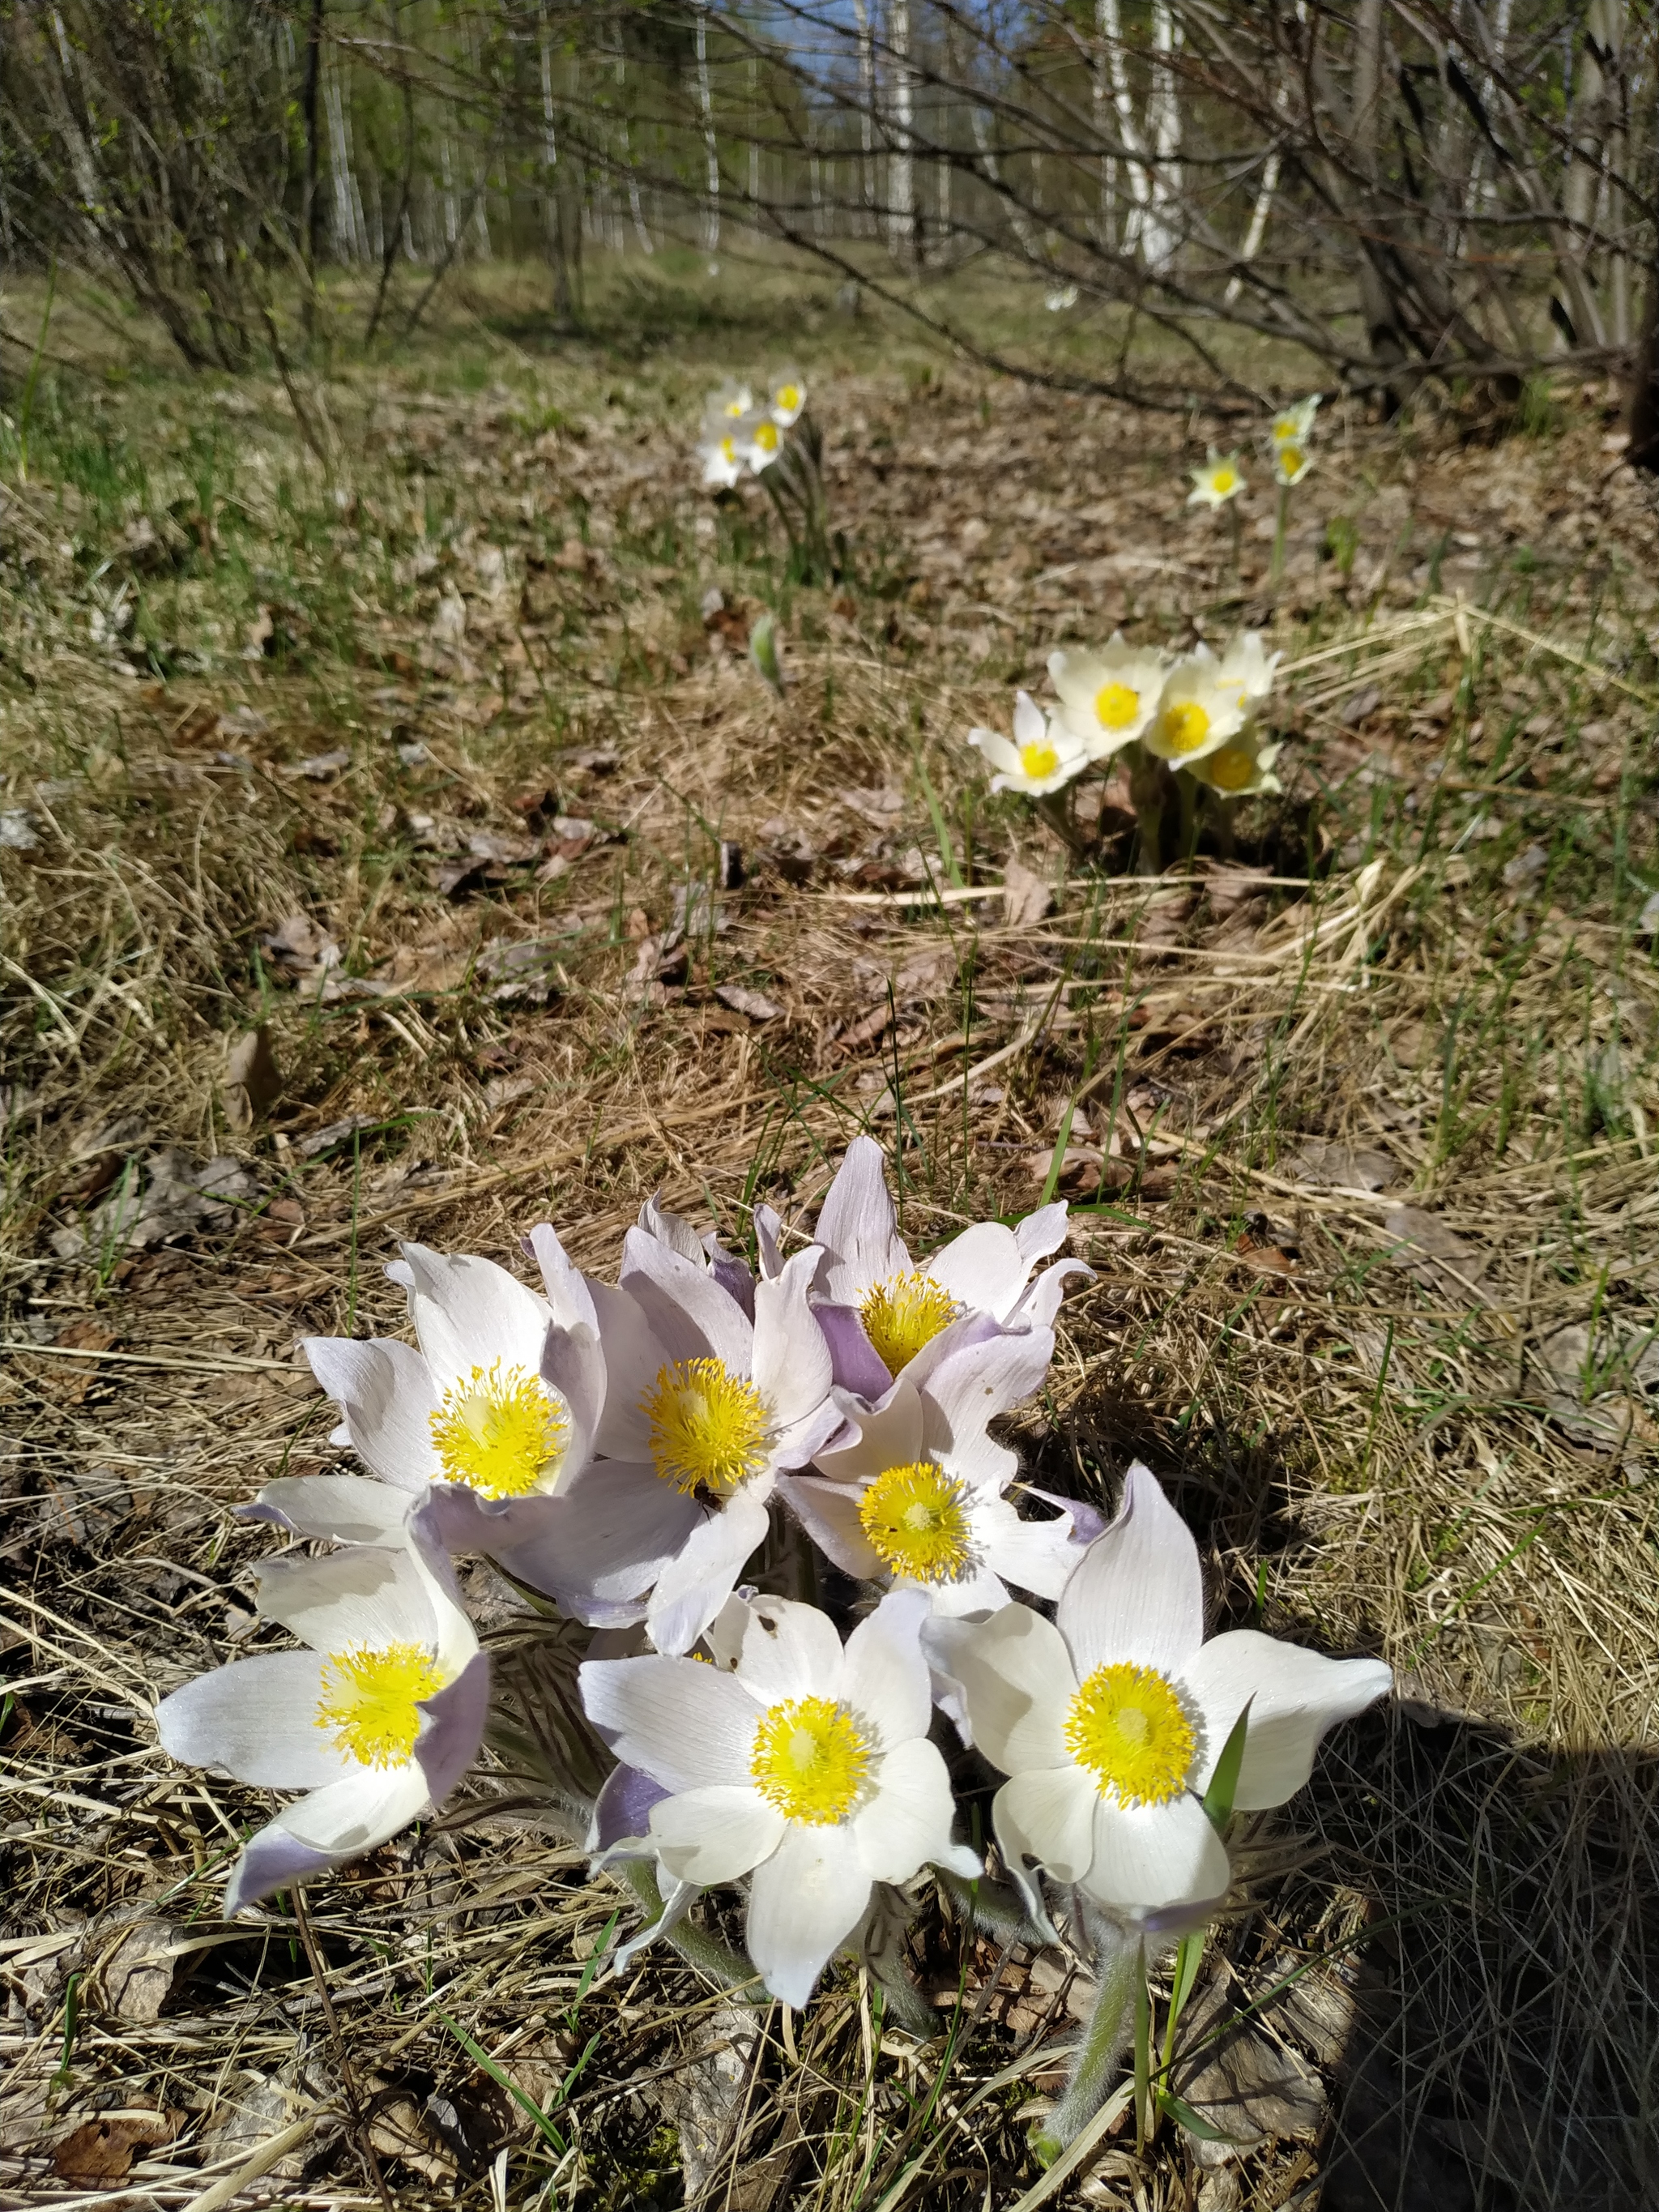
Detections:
[814, 1137, 1088, 1389]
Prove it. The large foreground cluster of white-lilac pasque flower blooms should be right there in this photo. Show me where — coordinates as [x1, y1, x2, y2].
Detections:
[157, 1141, 1389, 2004]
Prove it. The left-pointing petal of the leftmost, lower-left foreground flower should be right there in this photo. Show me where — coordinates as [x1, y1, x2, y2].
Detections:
[155, 1652, 356, 1790]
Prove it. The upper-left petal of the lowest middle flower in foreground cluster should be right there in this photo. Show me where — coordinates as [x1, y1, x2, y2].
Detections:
[578, 1657, 761, 1790]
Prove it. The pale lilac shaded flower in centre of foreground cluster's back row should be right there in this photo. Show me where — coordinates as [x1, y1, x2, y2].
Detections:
[497, 1228, 841, 1652]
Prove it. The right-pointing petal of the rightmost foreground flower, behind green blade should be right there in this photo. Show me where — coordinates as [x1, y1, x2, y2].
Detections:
[1181, 1628, 1393, 1812]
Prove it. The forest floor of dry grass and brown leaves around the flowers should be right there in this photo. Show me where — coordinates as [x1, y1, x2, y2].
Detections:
[0, 258, 1659, 2212]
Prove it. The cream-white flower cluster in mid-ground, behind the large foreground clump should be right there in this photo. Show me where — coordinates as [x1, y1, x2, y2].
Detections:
[969, 630, 1281, 799]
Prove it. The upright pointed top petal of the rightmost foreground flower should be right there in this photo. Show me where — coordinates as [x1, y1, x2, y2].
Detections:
[1057, 1460, 1203, 1681]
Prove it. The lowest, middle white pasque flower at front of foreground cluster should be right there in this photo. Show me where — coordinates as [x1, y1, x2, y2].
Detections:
[579, 1591, 982, 2006]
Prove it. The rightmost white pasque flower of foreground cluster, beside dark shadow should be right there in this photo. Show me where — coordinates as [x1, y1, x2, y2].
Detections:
[927, 1464, 1393, 1920]
